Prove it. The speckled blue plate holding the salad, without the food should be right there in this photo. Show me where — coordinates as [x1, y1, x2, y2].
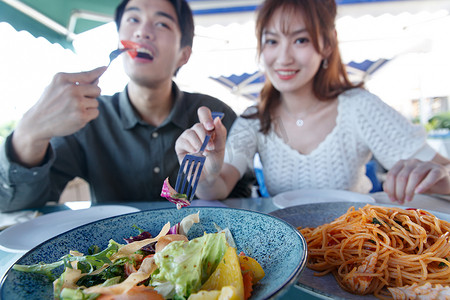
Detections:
[0, 207, 307, 300]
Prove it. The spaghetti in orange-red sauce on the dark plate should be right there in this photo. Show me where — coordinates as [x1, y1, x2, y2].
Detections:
[298, 204, 450, 299]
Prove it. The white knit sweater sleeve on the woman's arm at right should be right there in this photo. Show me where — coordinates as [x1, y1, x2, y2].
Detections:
[349, 89, 436, 170]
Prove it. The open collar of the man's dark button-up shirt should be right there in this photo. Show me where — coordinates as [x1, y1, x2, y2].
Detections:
[119, 82, 189, 129]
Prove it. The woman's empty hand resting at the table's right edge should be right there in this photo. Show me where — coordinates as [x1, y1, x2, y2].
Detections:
[383, 155, 450, 204]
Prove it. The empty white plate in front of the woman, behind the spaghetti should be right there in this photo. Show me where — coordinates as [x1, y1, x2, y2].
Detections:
[273, 189, 375, 208]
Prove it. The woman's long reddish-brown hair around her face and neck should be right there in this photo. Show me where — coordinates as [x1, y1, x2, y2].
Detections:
[251, 0, 362, 134]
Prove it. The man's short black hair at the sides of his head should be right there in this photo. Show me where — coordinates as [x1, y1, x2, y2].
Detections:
[114, 0, 194, 48]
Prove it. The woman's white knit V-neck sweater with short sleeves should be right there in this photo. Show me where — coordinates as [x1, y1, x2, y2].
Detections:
[225, 89, 436, 195]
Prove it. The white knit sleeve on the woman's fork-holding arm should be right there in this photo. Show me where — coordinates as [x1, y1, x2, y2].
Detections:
[224, 117, 258, 177]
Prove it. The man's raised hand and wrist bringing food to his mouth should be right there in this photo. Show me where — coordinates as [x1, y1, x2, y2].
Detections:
[12, 67, 106, 166]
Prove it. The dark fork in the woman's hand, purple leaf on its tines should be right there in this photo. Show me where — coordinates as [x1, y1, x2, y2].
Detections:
[175, 112, 224, 201]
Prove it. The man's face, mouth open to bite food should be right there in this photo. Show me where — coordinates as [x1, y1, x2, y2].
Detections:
[119, 0, 191, 87]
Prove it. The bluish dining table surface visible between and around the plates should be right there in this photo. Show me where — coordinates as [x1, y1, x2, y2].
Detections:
[0, 192, 450, 300]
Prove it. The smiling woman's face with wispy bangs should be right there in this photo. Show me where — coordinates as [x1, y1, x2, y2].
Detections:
[261, 9, 323, 94]
